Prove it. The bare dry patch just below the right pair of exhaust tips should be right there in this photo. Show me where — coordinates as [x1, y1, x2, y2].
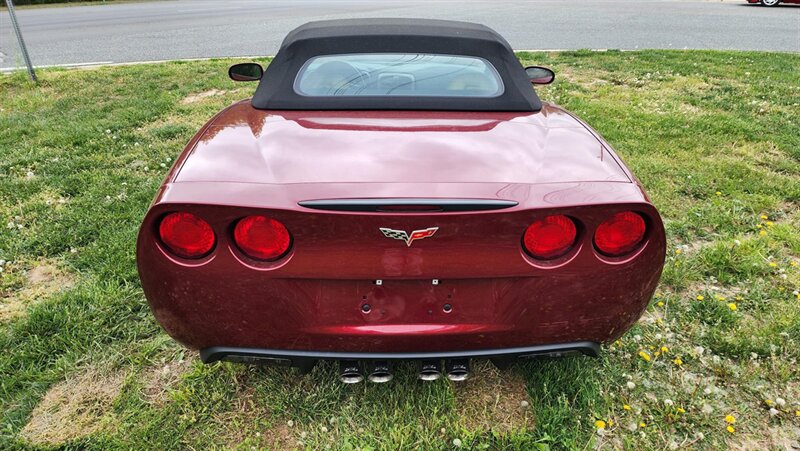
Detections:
[454, 361, 533, 434]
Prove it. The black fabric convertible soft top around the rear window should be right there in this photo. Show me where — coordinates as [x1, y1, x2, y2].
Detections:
[252, 19, 542, 111]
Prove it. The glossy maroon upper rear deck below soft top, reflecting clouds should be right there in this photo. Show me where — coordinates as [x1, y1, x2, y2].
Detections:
[174, 103, 630, 184]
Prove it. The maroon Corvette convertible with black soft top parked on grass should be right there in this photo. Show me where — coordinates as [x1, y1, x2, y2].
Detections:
[137, 19, 665, 382]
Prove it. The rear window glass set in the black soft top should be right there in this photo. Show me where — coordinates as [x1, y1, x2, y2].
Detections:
[294, 53, 503, 97]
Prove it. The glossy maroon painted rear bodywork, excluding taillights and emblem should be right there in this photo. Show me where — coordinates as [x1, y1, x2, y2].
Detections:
[137, 101, 665, 352]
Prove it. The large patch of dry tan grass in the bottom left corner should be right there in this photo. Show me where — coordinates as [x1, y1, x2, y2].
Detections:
[20, 369, 125, 445]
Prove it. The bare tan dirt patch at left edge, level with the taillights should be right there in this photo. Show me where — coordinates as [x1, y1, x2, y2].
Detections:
[0, 260, 75, 322]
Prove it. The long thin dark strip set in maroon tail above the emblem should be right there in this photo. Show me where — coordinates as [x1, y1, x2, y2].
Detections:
[297, 198, 519, 213]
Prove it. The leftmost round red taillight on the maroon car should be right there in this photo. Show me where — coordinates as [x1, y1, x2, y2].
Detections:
[158, 212, 216, 258]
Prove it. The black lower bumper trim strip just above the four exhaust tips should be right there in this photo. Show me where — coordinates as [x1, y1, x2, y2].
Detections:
[200, 341, 600, 368]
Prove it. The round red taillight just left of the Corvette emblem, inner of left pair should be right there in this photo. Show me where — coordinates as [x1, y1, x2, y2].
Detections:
[233, 216, 292, 260]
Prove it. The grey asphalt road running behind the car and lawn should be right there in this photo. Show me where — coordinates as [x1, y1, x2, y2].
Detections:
[0, 0, 800, 68]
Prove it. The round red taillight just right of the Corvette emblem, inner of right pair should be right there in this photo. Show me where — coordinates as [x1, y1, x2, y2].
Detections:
[522, 215, 578, 260]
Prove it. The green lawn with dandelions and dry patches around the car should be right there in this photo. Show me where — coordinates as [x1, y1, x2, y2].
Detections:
[0, 51, 800, 449]
